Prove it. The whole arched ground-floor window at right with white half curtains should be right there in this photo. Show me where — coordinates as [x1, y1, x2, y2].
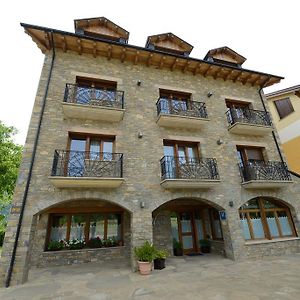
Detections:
[239, 198, 296, 240]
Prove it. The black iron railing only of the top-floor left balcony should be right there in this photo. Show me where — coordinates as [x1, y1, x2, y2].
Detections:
[64, 83, 124, 108]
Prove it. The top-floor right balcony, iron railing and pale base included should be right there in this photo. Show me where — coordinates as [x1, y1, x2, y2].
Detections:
[226, 108, 272, 136]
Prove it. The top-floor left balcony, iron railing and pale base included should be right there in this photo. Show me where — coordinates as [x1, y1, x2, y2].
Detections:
[63, 83, 125, 122]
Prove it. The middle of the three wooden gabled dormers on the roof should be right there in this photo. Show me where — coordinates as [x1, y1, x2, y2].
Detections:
[145, 32, 193, 54]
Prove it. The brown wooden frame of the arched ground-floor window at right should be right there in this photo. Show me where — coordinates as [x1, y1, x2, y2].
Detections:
[239, 198, 297, 240]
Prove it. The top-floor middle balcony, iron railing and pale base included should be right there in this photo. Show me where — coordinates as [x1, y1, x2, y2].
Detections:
[156, 98, 209, 129]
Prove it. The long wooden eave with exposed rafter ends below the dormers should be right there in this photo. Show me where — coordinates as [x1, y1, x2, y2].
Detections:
[21, 23, 283, 88]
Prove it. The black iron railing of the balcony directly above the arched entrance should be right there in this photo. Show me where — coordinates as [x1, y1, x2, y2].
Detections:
[160, 156, 219, 180]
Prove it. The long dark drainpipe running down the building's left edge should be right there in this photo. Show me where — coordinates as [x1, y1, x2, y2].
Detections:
[5, 31, 55, 287]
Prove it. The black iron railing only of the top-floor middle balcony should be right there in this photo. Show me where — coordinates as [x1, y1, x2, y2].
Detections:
[156, 98, 208, 118]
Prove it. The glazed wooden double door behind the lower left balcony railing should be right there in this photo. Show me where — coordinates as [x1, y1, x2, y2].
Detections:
[67, 136, 114, 177]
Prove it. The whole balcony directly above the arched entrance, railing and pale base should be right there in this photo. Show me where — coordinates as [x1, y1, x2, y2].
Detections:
[160, 156, 220, 189]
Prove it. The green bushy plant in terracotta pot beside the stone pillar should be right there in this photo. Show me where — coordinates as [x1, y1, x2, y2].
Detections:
[134, 241, 155, 275]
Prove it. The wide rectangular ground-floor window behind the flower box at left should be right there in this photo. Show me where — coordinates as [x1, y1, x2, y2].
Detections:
[47, 212, 123, 244]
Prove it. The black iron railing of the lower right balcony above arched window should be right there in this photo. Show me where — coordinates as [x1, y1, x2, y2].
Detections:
[239, 161, 292, 182]
